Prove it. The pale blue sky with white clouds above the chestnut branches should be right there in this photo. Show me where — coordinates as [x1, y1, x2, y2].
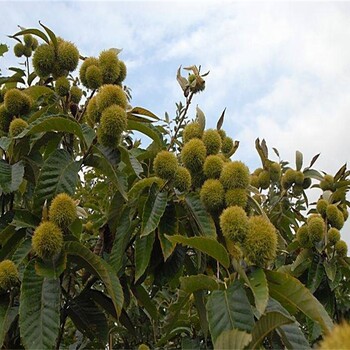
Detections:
[0, 1, 350, 173]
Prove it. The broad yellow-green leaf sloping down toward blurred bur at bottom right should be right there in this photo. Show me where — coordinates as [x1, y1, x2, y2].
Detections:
[265, 270, 333, 333]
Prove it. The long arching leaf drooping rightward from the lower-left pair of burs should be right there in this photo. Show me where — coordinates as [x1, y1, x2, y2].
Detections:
[64, 242, 124, 315]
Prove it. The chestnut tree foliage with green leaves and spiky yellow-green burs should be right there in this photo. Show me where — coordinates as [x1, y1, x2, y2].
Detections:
[0, 24, 350, 349]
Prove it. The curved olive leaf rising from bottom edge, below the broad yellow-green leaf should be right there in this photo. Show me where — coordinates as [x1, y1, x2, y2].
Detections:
[249, 312, 293, 349]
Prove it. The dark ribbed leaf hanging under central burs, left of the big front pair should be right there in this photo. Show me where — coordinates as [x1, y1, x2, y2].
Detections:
[186, 193, 216, 237]
